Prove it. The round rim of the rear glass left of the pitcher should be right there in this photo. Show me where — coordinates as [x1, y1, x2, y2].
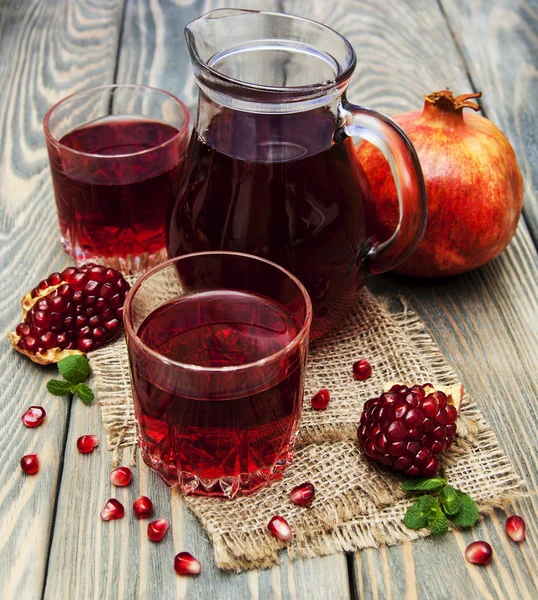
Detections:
[43, 83, 190, 160]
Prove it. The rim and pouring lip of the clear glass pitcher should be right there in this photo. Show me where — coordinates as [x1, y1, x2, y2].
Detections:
[185, 8, 357, 101]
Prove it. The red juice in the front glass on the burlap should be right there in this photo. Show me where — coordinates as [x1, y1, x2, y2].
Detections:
[131, 290, 303, 496]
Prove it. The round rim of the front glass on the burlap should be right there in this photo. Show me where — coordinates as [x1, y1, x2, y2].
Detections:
[123, 250, 312, 373]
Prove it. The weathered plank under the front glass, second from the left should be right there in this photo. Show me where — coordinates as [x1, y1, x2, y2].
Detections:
[45, 0, 350, 600]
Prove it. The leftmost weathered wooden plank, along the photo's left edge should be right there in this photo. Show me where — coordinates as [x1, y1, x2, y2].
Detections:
[0, 0, 122, 598]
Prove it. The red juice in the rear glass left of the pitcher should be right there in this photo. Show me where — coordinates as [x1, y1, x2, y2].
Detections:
[49, 117, 184, 272]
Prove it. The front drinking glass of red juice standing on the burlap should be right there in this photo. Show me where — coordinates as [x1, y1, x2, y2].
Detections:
[124, 252, 312, 497]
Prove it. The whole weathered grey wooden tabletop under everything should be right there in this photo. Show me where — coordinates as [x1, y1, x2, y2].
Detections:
[0, 0, 538, 600]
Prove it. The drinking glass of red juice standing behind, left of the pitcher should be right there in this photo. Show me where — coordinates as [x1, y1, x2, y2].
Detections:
[43, 85, 189, 274]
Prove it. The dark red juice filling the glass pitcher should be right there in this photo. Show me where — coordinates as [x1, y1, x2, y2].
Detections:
[167, 109, 371, 339]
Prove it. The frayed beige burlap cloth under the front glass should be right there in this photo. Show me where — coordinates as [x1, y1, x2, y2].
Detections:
[91, 290, 523, 571]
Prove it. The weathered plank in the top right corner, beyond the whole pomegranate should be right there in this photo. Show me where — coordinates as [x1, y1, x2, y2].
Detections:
[439, 0, 538, 247]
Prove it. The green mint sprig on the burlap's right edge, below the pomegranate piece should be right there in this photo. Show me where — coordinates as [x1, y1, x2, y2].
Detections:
[402, 477, 479, 535]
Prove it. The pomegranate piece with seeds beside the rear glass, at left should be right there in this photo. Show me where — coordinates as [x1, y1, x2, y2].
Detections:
[8, 265, 129, 365]
